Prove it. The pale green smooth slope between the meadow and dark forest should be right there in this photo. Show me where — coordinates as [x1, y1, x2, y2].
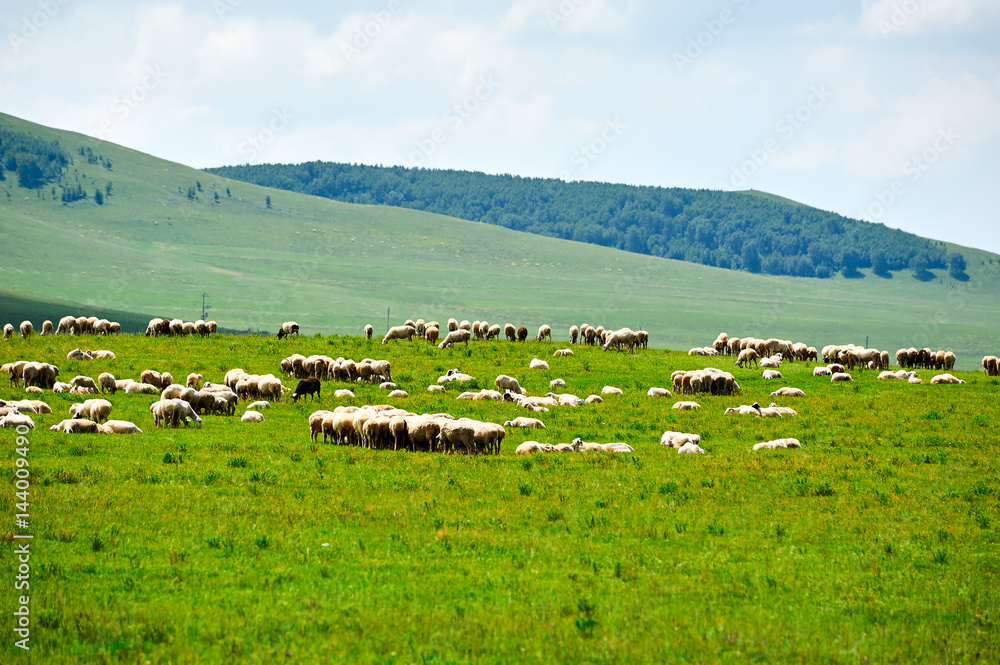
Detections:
[0, 115, 1000, 366]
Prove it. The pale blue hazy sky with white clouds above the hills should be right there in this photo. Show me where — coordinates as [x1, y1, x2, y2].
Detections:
[0, 0, 1000, 252]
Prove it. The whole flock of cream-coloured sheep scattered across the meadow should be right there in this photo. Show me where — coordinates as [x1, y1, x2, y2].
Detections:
[0, 316, 988, 454]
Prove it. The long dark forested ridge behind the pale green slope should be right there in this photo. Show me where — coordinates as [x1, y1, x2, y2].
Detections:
[206, 162, 967, 280]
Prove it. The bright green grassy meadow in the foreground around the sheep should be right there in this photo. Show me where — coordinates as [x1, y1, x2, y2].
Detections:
[0, 335, 1000, 664]
